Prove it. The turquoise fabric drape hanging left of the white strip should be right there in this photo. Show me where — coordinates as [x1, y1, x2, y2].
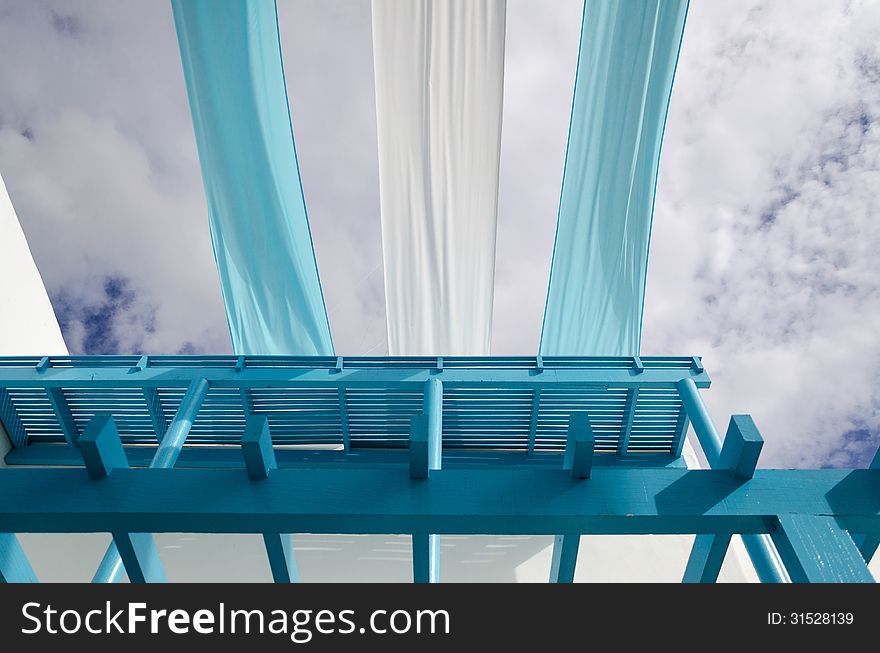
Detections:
[171, 0, 333, 355]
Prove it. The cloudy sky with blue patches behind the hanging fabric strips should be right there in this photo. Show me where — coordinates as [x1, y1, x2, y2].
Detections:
[0, 0, 880, 467]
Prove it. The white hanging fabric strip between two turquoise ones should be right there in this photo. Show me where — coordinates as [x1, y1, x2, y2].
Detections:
[372, 0, 506, 356]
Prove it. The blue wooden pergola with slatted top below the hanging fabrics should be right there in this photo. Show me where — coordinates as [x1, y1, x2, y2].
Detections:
[0, 356, 880, 582]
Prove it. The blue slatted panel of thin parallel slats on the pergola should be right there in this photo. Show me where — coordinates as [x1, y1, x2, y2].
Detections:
[0, 356, 694, 454]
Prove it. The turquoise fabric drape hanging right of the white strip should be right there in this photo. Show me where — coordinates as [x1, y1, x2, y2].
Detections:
[540, 0, 688, 356]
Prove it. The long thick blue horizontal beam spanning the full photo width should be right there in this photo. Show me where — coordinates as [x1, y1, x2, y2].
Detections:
[0, 467, 880, 535]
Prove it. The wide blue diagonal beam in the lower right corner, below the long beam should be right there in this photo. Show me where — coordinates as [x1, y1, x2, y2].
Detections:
[771, 514, 874, 583]
